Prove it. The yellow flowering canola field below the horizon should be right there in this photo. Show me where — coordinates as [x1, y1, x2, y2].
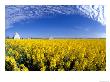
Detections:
[5, 39, 106, 71]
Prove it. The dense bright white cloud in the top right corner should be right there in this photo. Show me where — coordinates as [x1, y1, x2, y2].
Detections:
[77, 5, 105, 25]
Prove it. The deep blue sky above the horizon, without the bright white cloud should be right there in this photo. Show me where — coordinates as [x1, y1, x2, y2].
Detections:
[6, 6, 106, 38]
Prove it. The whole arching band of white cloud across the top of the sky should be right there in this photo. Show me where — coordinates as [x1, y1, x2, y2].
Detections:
[6, 5, 105, 29]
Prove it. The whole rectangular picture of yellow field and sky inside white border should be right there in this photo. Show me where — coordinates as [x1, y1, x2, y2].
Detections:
[5, 5, 106, 71]
